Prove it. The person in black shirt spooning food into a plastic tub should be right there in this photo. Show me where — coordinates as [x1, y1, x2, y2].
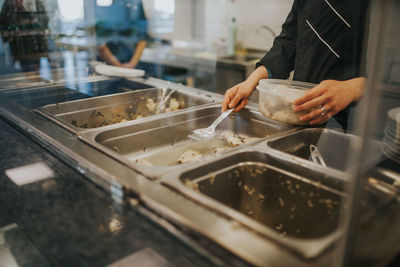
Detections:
[222, 0, 369, 130]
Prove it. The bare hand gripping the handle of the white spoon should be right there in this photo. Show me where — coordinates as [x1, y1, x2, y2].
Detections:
[222, 66, 268, 112]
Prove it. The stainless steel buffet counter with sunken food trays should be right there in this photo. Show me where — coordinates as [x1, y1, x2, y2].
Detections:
[0, 76, 399, 266]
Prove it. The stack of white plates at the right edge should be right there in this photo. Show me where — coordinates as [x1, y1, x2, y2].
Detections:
[382, 107, 400, 164]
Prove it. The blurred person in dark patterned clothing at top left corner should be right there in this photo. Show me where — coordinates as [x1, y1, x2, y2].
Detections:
[0, 0, 49, 72]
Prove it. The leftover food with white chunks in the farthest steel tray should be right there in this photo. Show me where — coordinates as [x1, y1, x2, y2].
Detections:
[71, 98, 186, 128]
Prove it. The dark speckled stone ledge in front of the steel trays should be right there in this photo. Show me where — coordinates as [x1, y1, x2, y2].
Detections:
[0, 119, 250, 266]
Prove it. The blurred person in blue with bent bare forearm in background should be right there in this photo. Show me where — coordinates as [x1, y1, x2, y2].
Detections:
[99, 1, 147, 68]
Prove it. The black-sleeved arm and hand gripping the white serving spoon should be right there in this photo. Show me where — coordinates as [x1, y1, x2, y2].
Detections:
[222, 0, 298, 111]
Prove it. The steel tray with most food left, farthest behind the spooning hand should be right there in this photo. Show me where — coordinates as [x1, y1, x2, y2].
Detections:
[37, 84, 214, 133]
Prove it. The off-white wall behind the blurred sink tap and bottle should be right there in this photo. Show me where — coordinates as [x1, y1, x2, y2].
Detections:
[173, 0, 293, 50]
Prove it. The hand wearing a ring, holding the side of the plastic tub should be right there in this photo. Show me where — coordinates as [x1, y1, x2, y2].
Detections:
[293, 77, 366, 125]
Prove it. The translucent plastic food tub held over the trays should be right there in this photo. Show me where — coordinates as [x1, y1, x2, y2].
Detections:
[257, 79, 316, 125]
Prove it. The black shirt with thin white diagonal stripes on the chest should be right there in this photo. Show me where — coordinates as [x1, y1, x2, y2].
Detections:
[257, 0, 369, 129]
